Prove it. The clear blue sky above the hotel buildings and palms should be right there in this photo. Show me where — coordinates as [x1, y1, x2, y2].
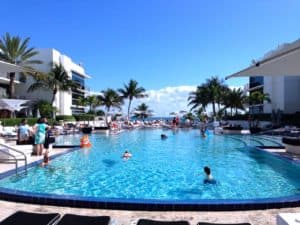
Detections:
[0, 0, 300, 114]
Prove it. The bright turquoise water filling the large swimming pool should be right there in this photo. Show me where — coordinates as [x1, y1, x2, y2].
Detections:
[0, 130, 300, 200]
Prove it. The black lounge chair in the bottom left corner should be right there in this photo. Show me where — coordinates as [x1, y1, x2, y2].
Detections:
[0, 211, 60, 225]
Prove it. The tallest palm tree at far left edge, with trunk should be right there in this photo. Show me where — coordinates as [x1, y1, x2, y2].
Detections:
[0, 33, 42, 98]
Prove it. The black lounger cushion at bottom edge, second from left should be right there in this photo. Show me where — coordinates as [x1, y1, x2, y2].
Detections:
[57, 214, 110, 225]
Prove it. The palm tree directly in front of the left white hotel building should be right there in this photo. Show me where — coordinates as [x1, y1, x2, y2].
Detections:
[28, 64, 77, 110]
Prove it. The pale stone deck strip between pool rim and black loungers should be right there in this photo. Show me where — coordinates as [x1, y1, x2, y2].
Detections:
[0, 201, 300, 225]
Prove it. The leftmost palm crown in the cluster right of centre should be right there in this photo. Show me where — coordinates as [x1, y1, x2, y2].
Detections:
[188, 85, 209, 111]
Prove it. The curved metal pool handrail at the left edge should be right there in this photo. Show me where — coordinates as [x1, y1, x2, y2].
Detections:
[0, 143, 27, 174]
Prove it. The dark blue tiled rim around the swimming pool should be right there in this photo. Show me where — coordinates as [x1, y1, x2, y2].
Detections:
[0, 144, 300, 211]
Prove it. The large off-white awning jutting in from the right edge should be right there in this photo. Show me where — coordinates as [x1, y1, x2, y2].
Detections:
[225, 40, 300, 79]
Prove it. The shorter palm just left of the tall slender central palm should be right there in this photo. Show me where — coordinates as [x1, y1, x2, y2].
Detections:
[98, 88, 123, 123]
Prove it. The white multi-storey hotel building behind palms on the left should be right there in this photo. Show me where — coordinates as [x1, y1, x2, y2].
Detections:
[10, 49, 90, 115]
